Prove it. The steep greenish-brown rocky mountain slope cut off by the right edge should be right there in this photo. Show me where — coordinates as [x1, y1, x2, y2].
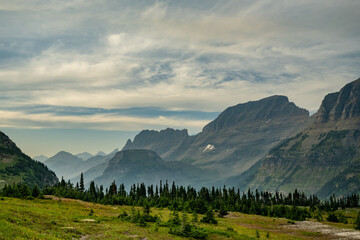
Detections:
[228, 79, 360, 197]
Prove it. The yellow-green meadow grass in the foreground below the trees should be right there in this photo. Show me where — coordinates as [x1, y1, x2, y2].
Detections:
[0, 198, 356, 240]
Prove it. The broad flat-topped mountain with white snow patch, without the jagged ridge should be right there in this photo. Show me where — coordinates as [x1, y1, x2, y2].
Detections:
[177, 96, 309, 174]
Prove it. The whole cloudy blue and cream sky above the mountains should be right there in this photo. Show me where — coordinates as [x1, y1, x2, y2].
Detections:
[0, 0, 360, 157]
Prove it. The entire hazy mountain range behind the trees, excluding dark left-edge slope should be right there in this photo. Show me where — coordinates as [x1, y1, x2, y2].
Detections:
[31, 79, 360, 197]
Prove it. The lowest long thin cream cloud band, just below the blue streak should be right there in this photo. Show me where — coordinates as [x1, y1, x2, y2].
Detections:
[0, 110, 214, 133]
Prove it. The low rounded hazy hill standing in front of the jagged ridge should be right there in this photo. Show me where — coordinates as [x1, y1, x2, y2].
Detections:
[95, 149, 212, 186]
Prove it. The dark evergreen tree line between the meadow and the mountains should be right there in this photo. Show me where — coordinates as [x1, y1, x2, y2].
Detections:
[0, 174, 359, 220]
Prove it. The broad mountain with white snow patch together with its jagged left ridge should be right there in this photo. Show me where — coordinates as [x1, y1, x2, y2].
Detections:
[123, 96, 309, 178]
